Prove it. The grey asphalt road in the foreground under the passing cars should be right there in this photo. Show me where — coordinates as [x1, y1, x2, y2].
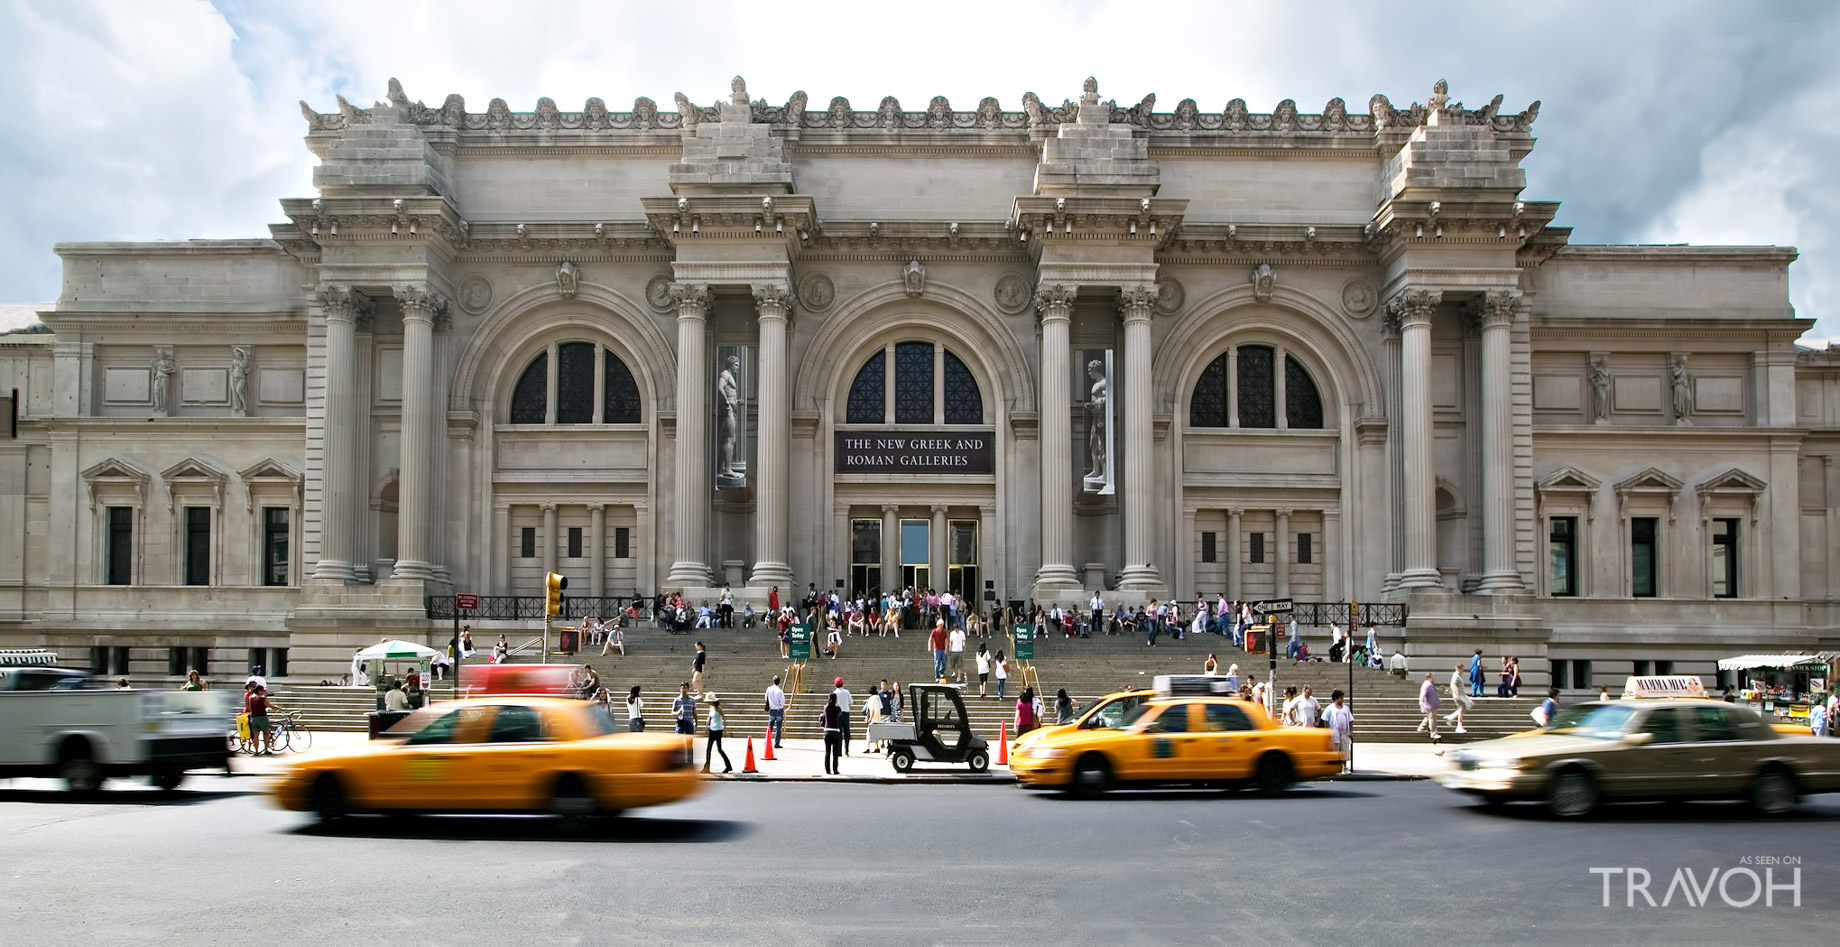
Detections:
[0, 778, 1840, 947]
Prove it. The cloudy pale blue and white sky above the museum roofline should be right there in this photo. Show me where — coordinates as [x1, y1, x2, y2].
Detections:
[0, 0, 1840, 338]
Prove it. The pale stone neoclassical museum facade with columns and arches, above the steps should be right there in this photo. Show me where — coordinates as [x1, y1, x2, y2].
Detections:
[0, 79, 1840, 688]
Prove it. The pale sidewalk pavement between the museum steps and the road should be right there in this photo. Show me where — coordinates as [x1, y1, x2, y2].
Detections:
[230, 730, 1452, 785]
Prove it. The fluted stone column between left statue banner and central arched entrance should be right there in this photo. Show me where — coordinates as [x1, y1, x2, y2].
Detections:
[747, 283, 793, 588]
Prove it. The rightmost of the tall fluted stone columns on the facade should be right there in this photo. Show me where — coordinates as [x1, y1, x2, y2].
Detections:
[1472, 291, 1522, 592]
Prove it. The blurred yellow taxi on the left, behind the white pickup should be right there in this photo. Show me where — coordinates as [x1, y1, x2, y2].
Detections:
[272, 697, 701, 822]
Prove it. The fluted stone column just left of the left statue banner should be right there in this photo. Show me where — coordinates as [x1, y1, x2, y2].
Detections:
[664, 283, 710, 588]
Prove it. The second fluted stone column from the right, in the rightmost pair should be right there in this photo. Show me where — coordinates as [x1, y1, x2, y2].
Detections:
[1387, 289, 1443, 588]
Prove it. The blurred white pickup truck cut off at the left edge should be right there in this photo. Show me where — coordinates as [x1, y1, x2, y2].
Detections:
[0, 667, 236, 793]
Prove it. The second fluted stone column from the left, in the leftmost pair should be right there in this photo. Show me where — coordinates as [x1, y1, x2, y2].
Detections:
[392, 287, 447, 581]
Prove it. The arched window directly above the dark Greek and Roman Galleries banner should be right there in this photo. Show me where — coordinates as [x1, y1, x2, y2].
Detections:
[845, 342, 984, 425]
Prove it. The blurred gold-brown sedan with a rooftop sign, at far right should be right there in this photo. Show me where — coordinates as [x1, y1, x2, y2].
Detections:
[1439, 699, 1840, 818]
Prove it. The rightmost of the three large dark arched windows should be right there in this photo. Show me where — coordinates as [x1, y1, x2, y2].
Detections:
[1189, 344, 1323, 430]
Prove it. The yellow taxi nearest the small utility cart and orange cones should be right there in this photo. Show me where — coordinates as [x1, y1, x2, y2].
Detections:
[1010, 693, 1341, 794]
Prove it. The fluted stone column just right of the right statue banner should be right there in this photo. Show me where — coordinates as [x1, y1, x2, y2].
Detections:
[1111, 283, 1163, 592]
